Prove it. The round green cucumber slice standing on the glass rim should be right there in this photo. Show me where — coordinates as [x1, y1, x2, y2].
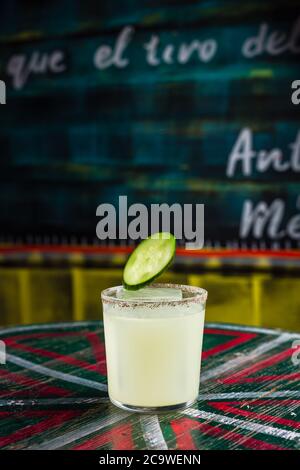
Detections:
[123, 232, 176, 290]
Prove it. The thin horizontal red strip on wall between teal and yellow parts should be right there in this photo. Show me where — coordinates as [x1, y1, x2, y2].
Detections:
[0, 245, 300, 259]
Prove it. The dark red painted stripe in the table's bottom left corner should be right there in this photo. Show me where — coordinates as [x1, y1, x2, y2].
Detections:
[0, 410, 78, 447]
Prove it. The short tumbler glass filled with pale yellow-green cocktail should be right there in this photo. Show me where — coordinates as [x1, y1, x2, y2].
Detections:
[101, 284, 207, 413]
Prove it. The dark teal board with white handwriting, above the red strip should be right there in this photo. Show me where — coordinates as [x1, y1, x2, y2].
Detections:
[0, 0, 300, 249]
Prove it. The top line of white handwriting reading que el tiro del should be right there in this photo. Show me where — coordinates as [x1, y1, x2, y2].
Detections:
[6, 17, 300, 89]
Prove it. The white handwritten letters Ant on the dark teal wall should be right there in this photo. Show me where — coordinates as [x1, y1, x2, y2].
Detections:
[226, 128, 300, 178]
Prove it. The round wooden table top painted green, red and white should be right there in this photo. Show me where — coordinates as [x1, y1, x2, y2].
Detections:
[0, 322, 300, 450]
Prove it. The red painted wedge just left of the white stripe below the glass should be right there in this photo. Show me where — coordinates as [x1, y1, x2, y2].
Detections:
[72, 423, 135, 450]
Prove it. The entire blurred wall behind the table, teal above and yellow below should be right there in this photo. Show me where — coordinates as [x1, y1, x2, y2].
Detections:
[0, 0, 300, 331]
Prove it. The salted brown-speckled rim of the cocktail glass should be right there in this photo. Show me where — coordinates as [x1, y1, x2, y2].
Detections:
[101, 283, 207, 307]
